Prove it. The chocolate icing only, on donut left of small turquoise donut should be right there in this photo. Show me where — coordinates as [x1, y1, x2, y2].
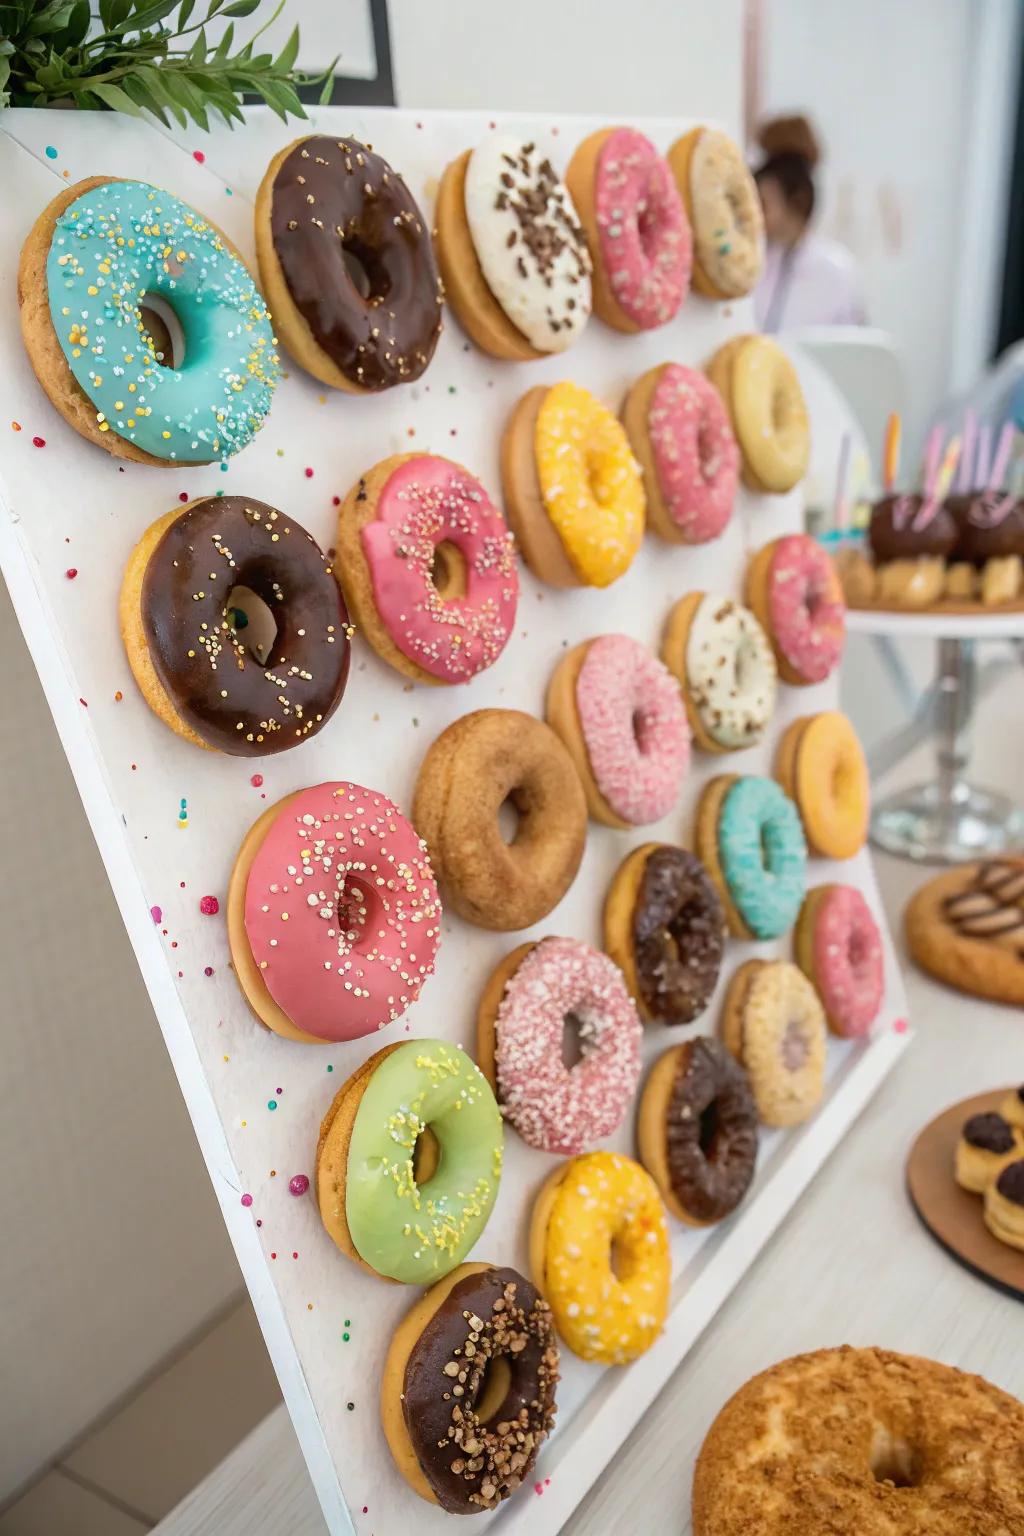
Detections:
[633, 846, 725, 1025]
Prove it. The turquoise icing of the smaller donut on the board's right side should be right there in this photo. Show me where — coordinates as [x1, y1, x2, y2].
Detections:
[718, 777, 808, 938]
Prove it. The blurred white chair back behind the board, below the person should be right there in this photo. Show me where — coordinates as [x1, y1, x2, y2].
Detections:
[780, 326, 907, 462]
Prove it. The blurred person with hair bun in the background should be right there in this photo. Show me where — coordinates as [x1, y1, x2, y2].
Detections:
[754, 117, 864, 333]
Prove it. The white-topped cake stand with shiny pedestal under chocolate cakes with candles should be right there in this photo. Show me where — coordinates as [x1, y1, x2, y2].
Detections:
[847, 608, 1024, 863]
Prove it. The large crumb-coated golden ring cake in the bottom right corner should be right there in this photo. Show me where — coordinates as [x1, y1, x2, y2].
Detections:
[692, 1344, 1024, 1536]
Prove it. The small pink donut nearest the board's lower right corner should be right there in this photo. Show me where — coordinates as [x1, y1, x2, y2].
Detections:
[795, 885, 884, 1040]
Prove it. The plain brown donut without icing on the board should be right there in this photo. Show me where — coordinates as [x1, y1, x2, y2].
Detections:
[413, 710, 586, 932]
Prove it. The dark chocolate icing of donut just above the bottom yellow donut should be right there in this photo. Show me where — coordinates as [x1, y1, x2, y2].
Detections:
[665, 1038, 757, 1223]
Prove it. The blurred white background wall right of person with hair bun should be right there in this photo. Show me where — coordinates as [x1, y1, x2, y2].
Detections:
[761, 0, 1001, 452]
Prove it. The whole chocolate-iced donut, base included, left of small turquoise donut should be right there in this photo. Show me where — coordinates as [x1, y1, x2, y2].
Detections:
[603, 843, 726, 1025]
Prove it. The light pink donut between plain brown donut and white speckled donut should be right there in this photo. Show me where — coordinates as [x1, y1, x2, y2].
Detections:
[547, 634, 689, 828]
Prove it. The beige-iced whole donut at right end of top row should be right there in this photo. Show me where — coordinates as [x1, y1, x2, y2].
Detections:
[668, 127, 765, 300]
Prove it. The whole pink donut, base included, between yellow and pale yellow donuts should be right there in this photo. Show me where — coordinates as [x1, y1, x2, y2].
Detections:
[622, 362, 740, 544]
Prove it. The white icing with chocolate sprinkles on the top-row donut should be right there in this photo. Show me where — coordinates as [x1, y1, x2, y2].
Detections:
[465, 134, 591, 352]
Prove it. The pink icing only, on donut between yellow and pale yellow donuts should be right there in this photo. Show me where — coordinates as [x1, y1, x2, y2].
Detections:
[646, 362, 740, 544]
